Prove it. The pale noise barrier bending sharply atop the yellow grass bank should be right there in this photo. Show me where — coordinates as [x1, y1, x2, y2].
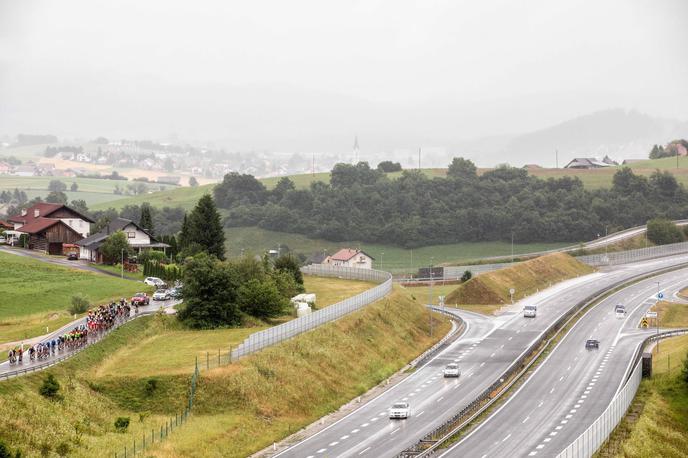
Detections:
[231, 265, 392, 361]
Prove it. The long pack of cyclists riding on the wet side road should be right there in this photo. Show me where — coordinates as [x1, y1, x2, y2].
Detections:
[7, 298, 138, 364]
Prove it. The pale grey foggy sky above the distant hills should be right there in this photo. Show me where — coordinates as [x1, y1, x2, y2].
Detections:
[0, 0, 688, 154]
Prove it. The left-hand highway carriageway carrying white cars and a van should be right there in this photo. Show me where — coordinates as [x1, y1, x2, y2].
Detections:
[276, 255, 688, 458]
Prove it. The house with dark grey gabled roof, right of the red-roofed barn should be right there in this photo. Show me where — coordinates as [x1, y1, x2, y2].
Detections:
[76, 218, 169, 263]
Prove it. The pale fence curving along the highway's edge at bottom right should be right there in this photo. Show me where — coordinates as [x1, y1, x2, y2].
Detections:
[557, 329, 686, 458]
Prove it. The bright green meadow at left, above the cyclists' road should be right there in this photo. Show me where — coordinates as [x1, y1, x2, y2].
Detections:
[0, 253, 150, 345]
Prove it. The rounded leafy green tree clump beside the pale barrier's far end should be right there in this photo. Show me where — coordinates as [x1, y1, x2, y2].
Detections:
[179, 253, 303, 329]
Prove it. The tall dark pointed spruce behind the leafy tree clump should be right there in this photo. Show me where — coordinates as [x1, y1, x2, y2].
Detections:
[184, 194, 225, 259]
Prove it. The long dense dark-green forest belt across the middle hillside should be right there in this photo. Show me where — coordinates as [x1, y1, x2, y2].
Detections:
[214, 158, 688, 247]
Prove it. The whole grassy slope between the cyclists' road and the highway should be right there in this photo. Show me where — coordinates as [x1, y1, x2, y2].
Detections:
[0, 284, 449, 457]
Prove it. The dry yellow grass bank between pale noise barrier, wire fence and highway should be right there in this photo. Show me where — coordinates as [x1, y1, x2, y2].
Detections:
[147, 287, 450, 457]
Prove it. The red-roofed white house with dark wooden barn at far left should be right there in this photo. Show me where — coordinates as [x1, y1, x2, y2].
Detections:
[8, 202, 94, 254]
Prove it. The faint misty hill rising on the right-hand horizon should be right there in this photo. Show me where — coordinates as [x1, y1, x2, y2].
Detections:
[481, 109, 688, 167]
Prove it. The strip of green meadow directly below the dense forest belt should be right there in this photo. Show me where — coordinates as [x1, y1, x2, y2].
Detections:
[225, 227, 570, 273]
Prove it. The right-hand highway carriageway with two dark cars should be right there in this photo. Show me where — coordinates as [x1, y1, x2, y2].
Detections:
[441, 268, 688, 457]
